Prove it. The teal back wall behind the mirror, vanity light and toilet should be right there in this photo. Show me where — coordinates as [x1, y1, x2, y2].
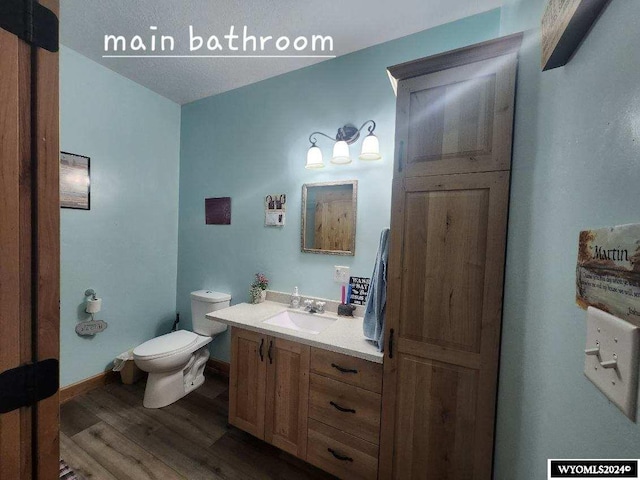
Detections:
[177, 10, 500, 360]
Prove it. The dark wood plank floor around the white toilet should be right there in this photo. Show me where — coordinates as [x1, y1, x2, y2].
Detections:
[60, 376, 335, 480]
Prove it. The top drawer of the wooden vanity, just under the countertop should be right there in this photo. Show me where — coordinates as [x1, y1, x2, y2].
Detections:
[311, 348, 382, 393]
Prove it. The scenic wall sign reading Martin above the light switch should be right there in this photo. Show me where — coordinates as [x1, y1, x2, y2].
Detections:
[576, 225, 640, 326]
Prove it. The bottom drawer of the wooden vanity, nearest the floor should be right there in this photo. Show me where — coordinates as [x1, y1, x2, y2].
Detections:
[307, 419, 378, 480]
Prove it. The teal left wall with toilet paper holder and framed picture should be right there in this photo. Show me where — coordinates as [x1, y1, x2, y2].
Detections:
[60, 47, 180, 386]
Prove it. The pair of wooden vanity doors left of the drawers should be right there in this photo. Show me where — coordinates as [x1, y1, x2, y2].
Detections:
[229, 327, 310, 459]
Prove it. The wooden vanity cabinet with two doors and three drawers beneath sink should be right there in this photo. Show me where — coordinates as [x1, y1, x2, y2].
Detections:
[229, 327, 382, 480]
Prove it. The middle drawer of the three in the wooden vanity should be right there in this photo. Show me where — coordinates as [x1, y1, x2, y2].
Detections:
[309, 373, 381, 445]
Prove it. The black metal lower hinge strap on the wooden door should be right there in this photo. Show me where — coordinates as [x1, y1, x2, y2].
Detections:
[0, 358, 59, 413]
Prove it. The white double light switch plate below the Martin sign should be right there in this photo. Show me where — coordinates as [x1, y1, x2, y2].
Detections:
[584, 307, 640, 420]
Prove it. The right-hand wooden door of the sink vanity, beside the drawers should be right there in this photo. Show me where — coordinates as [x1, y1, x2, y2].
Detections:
[265, 337, 310, 459]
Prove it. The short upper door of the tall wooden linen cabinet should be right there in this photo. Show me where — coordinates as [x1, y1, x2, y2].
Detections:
[396, 54, 516, 177]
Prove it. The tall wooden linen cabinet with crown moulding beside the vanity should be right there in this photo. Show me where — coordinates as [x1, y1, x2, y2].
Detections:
[378, 34, 522, 480]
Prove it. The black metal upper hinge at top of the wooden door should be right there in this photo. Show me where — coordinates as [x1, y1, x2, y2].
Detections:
[0, 0, 58, 52]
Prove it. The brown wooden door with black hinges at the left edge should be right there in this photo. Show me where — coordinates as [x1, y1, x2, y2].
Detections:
[0, 0, 60, 480]
